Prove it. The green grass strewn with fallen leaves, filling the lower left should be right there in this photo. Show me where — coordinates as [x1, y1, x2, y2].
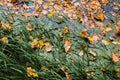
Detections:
[0, 8, 119, 80]
